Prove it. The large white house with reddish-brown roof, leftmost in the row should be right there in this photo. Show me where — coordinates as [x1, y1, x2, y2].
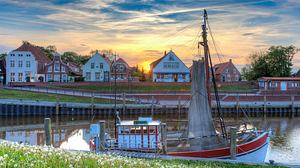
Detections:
[6, 42, 51, 83]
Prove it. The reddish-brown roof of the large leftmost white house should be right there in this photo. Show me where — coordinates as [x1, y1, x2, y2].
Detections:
[14, 42, 51, 64]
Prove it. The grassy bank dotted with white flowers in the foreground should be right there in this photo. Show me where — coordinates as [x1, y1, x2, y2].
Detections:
[0, 143, 278, 168]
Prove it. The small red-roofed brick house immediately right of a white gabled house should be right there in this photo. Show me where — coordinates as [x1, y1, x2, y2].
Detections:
[110, 58, 131, 82]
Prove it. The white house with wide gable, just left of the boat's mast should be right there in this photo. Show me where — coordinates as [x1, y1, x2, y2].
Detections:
[150, 51, 190, 82]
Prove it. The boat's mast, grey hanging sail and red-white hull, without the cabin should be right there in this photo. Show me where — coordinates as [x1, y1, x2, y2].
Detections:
[168, 10, 269, 163]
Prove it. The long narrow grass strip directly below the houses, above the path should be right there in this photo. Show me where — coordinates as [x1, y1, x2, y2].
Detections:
[50, 82, 251, 92]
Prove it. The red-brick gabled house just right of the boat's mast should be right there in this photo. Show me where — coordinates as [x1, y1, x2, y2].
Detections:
[214, 59, 241, 82]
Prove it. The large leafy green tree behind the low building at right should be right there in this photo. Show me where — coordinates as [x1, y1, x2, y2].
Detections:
[242, 46, 298, 80]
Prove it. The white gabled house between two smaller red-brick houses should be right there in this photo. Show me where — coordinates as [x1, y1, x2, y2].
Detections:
[82, 52, 110, 82]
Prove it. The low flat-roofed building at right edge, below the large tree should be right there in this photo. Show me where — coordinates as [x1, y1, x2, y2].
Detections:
[257, 77, 300, 92]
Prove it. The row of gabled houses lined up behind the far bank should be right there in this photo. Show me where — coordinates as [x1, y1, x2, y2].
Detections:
[0, 42, 241, 83]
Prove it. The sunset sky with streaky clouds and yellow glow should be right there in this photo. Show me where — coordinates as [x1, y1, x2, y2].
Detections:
[0, 0, 300, 70]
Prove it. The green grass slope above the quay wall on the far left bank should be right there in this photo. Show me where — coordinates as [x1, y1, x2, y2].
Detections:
[0, 89, 111, 104]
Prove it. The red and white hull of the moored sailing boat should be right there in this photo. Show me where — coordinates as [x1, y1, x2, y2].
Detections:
[168, 132, 269, 163]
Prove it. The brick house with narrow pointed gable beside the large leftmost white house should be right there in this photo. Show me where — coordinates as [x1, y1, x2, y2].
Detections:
[45, 53, 70, 82]
